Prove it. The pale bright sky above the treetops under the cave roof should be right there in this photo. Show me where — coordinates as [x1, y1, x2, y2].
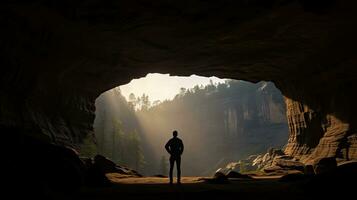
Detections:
[120, 73, 225, 102]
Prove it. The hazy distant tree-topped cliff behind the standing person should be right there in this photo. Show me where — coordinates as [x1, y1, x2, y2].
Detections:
[137, 81, 288, 175]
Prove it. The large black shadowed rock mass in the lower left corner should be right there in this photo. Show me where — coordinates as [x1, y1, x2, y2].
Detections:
[9, 133, 86, 199]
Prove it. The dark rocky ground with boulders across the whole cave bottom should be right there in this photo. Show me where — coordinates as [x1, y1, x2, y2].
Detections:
[11, 144, 357, 200]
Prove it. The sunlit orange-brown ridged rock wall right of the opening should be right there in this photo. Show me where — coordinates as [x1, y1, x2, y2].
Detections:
[285, 97, 356, 164]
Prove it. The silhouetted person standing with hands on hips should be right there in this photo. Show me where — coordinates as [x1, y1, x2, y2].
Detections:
[165, 131, 184, 184]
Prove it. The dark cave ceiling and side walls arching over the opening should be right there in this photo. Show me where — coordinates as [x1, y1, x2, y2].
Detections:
[0, 0, 357, 167]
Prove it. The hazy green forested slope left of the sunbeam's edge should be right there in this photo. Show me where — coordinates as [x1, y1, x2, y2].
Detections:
[82, 88, 145, 170]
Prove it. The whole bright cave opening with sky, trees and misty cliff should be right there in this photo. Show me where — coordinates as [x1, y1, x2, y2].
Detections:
[82, 74, 288, 176]
